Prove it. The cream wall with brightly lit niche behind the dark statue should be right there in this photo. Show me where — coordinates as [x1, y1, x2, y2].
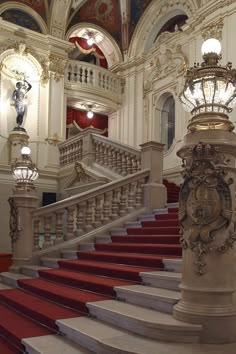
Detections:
[0, 19, 71, 252]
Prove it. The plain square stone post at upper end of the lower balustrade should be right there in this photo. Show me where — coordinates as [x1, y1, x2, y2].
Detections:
[140, 141, 167, 211]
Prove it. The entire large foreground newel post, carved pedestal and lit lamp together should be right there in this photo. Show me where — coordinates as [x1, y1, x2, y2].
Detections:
[174, 39, 236, 343]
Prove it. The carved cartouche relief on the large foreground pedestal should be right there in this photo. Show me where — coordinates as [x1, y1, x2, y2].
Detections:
[179, 143, 236, 275]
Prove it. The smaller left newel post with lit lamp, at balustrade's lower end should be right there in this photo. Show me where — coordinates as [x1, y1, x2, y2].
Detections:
[9, 146, 38, 272]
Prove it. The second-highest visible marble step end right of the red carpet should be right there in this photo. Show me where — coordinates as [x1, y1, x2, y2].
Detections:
[139, 271, 182, 290]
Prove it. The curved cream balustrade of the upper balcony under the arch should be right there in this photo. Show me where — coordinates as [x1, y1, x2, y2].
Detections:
[65, 60, 121, 98]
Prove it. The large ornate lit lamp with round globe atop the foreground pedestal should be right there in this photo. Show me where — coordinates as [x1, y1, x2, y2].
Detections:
[179, 38, 236, 132]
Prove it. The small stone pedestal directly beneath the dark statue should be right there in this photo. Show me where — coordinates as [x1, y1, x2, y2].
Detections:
[8, 130, 29, 162]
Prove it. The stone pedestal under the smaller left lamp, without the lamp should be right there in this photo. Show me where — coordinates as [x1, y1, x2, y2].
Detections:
[9, 190, 38, 272]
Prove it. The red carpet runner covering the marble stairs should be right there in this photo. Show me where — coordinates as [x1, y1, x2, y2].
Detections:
[0, 185, 181, 354]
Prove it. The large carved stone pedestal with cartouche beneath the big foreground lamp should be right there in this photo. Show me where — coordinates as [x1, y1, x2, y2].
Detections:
[174, 130, 236, 343]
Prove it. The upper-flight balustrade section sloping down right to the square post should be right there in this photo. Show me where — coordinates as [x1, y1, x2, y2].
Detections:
[92, 134, 141, 176]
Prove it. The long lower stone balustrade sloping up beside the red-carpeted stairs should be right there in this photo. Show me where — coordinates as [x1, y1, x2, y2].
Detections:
[31, 169, 150, 251]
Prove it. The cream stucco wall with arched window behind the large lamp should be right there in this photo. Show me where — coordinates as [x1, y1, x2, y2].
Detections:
[109, 0, 236, 182]
